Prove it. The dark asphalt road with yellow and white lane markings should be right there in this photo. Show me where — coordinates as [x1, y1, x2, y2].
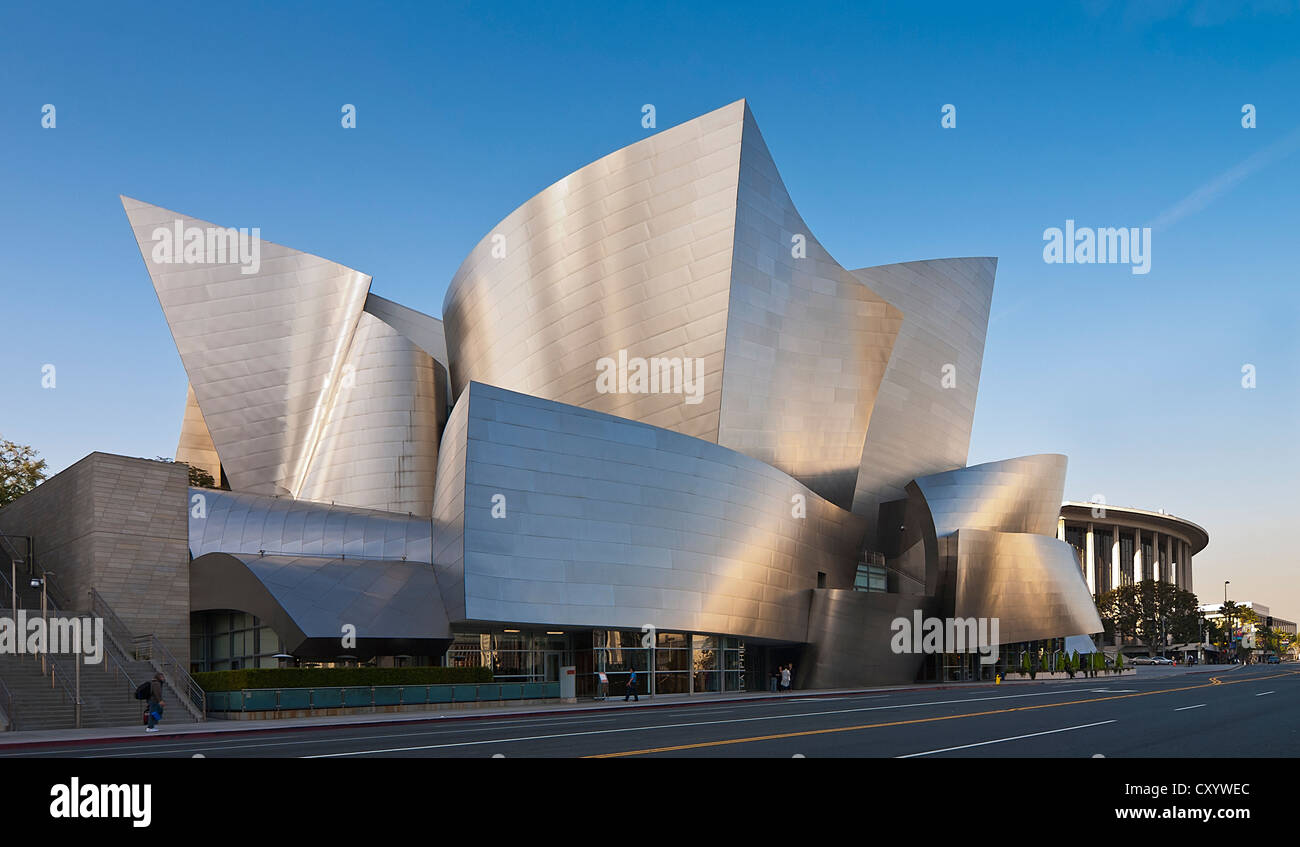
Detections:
[0, 665, 1300, 759]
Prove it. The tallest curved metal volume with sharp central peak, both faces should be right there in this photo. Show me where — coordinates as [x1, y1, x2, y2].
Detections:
[443, 100, 902, 508]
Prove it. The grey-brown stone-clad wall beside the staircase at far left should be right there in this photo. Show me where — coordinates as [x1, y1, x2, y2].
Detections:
[0, 452, 190, 668]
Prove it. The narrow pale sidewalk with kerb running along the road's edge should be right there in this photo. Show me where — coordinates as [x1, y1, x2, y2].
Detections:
[0, 665, 1242, 751]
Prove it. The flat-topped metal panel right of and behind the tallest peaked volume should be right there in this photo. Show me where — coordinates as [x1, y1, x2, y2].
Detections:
[853, 257, 997, 543]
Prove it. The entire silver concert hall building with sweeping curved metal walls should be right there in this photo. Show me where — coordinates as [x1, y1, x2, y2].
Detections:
[122, 101, 1102, 695]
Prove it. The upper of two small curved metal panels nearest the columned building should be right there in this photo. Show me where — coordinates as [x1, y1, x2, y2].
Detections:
[909, 453, 1067, 538]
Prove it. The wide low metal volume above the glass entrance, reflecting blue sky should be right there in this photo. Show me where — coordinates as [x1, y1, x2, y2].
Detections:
[434, 382, 865, 642]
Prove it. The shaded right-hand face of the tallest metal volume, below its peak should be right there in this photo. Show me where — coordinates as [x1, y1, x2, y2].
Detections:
[718, 109, 911, 508]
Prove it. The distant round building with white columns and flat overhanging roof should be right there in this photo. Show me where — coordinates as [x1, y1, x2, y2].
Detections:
[1057, 501, 1210, 598]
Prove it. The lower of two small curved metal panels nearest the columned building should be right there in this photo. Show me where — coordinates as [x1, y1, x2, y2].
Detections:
[954, 529, 1102, 644]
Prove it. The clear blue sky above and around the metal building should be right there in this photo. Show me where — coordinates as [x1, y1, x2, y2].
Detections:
[0, 0, 1300, 618]
